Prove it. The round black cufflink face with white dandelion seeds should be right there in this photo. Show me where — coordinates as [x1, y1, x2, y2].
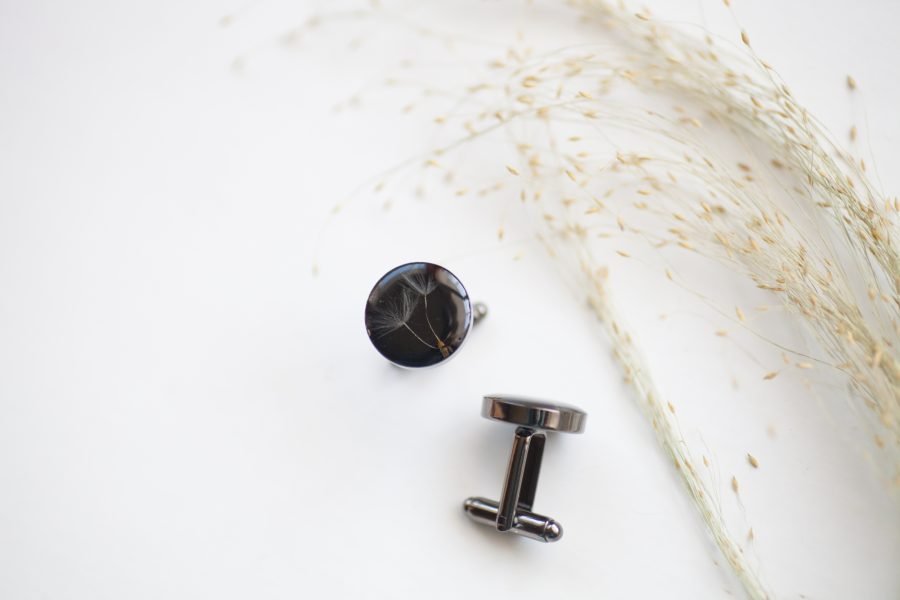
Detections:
[366, 262, 474, 368]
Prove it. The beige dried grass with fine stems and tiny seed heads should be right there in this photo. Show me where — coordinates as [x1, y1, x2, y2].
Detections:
[312, 0, 900, 598]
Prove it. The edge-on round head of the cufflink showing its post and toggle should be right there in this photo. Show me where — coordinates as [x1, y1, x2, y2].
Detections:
[481, 395, 587, 433]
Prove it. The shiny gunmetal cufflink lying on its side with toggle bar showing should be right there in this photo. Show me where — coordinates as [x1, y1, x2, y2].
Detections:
[463, 396, 587, 542]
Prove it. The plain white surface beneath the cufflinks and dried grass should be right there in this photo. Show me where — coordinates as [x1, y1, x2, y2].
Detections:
[0, 0, 900, 600]
